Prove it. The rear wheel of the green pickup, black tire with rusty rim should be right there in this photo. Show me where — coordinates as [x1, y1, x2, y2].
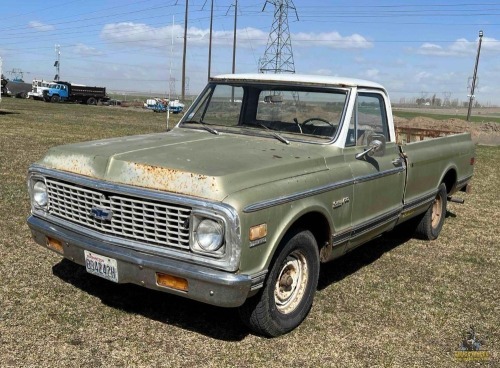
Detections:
[415, 183, 448, 240]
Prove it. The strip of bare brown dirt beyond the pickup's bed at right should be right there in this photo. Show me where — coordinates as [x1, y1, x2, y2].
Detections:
[394, 116, 500, 146]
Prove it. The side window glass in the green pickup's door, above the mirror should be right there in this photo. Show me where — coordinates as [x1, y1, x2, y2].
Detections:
[356, 93, 389, 146]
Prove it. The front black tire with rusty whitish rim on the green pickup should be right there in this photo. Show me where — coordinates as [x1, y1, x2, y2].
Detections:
[239, 230, 319, 337]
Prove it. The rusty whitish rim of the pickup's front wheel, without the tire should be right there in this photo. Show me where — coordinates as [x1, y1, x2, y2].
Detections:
[274, 251, 309, 314]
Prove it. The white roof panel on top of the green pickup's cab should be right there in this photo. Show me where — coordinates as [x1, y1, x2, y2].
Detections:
[210, 73, 385, 91]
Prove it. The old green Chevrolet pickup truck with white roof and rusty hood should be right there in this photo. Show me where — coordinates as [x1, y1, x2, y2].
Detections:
[28, 74, 474, 336]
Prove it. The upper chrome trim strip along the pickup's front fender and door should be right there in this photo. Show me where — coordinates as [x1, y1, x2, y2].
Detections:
[243, 167, 405, 213]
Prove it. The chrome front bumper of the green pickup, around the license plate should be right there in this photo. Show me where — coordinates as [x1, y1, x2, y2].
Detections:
[27, 215, 258, 307]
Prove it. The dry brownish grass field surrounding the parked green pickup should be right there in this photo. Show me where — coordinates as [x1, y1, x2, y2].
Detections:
[0, 99, 500, 367]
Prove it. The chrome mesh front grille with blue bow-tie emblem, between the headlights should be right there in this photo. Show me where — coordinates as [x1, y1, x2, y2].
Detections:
[46, 178, 191, 250]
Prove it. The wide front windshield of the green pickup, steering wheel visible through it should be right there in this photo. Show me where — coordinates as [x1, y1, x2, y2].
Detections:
[180, 83, 347, 140]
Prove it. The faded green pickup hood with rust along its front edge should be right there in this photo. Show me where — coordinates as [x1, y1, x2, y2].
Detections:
[39, 128, 327, 201]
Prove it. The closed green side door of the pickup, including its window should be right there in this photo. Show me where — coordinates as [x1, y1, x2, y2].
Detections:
[344, 91, 406, 248]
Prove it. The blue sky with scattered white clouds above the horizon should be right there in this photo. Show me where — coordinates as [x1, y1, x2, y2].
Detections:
[0, 0, 500, 106]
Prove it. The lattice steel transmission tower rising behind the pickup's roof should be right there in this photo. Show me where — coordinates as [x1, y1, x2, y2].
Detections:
[259, 0, 299, 73]
